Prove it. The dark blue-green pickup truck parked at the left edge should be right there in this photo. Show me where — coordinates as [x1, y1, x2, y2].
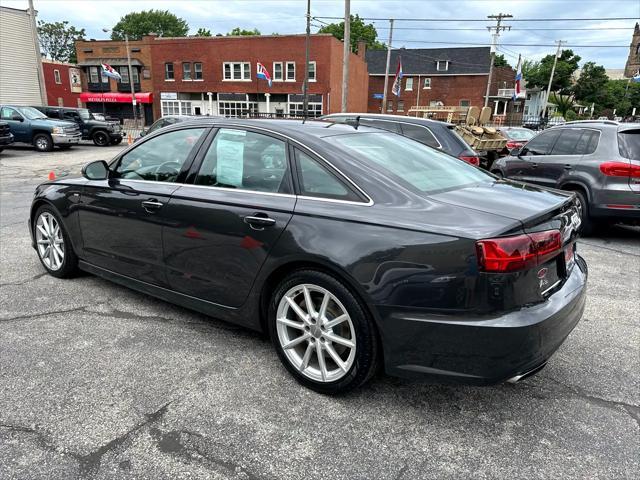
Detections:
[0, 105, 82, 152]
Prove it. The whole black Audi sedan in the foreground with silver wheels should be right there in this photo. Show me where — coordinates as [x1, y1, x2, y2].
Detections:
[29, 119, 587, 393]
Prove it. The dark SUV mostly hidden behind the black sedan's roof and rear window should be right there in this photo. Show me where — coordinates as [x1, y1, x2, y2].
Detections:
[319, 113, 480, 166]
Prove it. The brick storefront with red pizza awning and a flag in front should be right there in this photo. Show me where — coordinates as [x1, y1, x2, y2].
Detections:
[76, 35, 155, 125]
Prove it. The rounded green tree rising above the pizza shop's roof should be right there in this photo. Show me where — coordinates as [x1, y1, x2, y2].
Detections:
[111, 9, 189, 40]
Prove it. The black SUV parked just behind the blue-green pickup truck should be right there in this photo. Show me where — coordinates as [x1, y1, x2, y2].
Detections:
[33, 106, 122, 147]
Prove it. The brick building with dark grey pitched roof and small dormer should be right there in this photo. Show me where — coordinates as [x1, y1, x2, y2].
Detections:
[366, 47, 515, 115]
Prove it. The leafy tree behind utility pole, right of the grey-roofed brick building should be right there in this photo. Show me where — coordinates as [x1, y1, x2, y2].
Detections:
[522, 50, 580, 94]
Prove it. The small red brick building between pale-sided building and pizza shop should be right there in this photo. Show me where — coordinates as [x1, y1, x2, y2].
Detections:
[42, 59, 83, 108]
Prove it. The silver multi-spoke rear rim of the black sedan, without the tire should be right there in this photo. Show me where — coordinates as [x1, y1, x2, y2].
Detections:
[276, 284, 356, 383]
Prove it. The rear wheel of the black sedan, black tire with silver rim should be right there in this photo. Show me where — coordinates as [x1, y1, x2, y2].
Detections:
[268, 270, 379, 394]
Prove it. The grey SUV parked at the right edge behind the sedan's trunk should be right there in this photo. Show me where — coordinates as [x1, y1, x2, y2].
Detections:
[491, 120, 640, 234]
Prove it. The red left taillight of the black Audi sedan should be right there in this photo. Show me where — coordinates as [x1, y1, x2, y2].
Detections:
[476, 230, 562, 272]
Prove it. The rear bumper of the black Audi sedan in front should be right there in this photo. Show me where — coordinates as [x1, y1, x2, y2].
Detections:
[378, 257, 588, 385]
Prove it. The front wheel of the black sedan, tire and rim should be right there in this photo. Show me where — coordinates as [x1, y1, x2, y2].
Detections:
[32, 205, 78, 278]
